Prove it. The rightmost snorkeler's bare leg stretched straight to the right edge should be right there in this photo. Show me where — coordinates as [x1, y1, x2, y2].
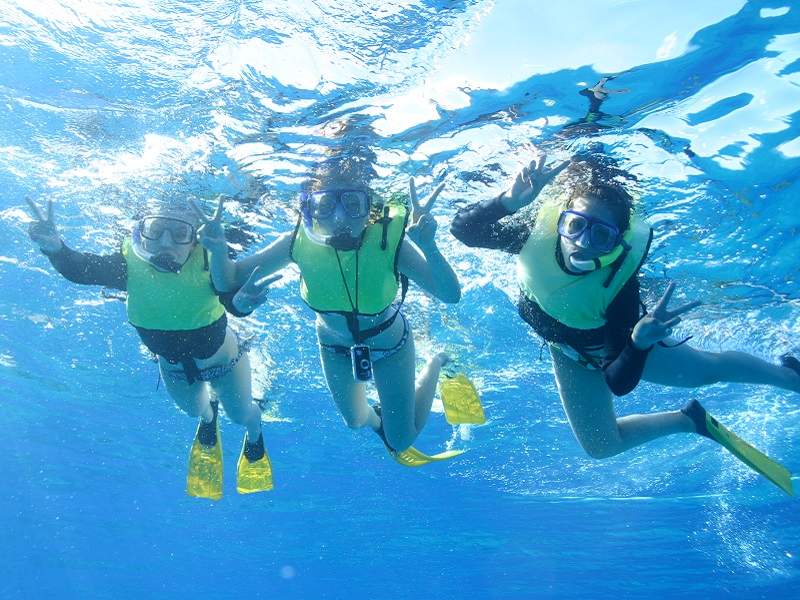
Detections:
[642, 340, 800, 392]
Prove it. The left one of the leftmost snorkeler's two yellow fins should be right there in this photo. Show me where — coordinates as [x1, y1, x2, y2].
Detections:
[186, 402, 222, 500]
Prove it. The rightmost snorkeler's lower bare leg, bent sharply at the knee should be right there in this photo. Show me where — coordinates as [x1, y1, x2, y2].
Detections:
[550, 350, 695, 458]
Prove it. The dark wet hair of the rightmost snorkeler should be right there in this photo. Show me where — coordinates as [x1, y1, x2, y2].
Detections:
[563, 155, 636, 231]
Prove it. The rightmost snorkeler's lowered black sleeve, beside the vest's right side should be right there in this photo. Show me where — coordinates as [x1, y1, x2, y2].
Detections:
[602, 275, 650, 396]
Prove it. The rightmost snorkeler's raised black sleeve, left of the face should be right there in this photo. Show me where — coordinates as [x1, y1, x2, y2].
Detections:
[450, 196, 531, 254]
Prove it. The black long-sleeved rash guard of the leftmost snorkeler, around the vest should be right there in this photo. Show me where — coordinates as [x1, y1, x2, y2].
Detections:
[44, 244, 246, 362]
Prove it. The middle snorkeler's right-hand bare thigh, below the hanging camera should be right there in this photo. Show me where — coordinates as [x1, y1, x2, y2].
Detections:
[372, 333, 417, 440]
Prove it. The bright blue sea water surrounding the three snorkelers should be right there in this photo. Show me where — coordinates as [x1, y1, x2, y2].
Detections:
[0, 0, 800, 599]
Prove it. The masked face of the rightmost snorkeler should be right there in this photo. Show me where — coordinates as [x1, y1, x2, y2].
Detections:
[559, 197, 619, 261]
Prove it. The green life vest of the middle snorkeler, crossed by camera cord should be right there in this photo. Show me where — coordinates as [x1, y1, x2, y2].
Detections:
[290, 205, 408, 315]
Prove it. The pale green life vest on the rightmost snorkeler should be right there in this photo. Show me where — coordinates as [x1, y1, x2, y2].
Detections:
[517, 201, 653, 329]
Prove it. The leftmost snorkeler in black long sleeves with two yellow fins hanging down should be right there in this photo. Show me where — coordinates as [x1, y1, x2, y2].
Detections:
[28, 200, 272, 500]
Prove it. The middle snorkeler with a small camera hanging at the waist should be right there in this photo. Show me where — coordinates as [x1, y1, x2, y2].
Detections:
[200, 156, 461, 466]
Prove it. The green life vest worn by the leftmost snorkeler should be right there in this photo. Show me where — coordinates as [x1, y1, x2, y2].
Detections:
[122, 238, 225, 331]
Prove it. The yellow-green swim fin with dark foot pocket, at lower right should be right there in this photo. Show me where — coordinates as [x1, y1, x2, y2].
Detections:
[681, 400, 794, 496]
